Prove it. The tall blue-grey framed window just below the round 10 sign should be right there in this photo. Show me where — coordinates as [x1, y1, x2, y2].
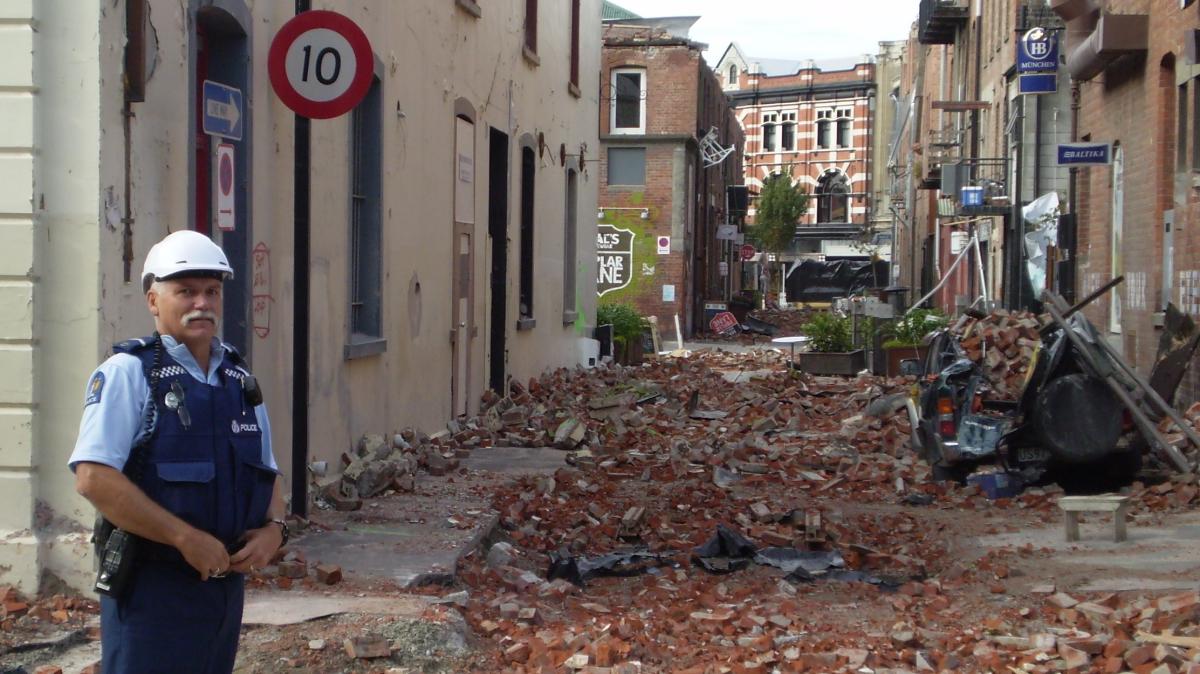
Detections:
[349, 78, 383, 345]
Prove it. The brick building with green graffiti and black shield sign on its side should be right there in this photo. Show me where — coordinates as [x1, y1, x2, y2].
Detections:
[596, 5, 743, 335]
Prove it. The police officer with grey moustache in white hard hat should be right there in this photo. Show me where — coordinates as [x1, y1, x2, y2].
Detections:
[70, 230, 288, 674]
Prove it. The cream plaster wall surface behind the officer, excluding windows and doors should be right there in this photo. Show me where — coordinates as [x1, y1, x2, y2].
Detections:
[11, 0, 600, 590]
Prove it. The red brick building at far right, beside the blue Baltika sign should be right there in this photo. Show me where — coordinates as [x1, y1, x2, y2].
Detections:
[1051, 0, 1200, 403]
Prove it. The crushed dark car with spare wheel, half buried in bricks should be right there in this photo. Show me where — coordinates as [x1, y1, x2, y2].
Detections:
[902, 303, 1146, 486]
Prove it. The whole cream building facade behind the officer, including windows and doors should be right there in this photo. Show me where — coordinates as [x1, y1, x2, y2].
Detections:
[0, 0, 600, 591]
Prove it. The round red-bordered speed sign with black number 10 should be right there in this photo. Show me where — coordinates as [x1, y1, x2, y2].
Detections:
[266, 10, 374, 120]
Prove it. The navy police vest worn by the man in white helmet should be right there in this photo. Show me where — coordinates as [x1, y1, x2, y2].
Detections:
[113, 336, 276, 544]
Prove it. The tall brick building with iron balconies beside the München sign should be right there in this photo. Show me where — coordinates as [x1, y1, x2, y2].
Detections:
[892, 0, 1070, 312]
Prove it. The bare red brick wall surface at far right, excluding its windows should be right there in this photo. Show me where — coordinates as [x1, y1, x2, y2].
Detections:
[1076, 0, 1200, 402]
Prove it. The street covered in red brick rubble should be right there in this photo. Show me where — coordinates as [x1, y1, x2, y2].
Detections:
[7, 350, 1200, 674]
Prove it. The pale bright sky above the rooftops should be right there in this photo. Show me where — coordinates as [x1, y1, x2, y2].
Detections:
[612, 0, 920, 65]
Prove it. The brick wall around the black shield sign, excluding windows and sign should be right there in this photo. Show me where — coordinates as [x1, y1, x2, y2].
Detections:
[595, 26, 744, 339]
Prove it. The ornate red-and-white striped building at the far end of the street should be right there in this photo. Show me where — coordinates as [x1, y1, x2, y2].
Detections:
[716, 43, 876, 259]
